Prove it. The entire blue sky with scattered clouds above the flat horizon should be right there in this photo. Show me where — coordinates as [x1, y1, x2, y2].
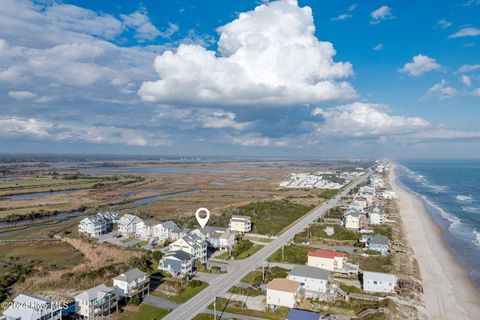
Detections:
[0, 0, 480, 158]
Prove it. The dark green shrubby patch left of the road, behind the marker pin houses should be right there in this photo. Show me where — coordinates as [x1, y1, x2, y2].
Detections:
[234, 200, 313, 234]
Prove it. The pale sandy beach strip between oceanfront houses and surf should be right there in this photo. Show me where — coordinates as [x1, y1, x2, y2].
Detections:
[389, 164, 480, 320]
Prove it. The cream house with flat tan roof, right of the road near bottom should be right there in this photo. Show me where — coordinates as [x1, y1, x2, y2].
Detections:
[267, 278, 300, 308]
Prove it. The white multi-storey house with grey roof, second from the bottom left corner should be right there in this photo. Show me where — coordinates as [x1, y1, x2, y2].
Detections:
[76, 284, 118, 319]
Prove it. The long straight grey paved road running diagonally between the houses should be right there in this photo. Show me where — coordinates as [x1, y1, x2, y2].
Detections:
[164, 171, 372, 320]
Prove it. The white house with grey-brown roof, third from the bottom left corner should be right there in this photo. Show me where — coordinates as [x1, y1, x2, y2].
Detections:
[113, 268, 150, 301]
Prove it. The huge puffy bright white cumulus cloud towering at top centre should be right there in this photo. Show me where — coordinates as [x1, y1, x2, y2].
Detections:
[138, 0, 355, 106]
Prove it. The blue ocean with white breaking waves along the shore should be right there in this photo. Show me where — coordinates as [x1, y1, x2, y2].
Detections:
[396, 160, 480, 290]
